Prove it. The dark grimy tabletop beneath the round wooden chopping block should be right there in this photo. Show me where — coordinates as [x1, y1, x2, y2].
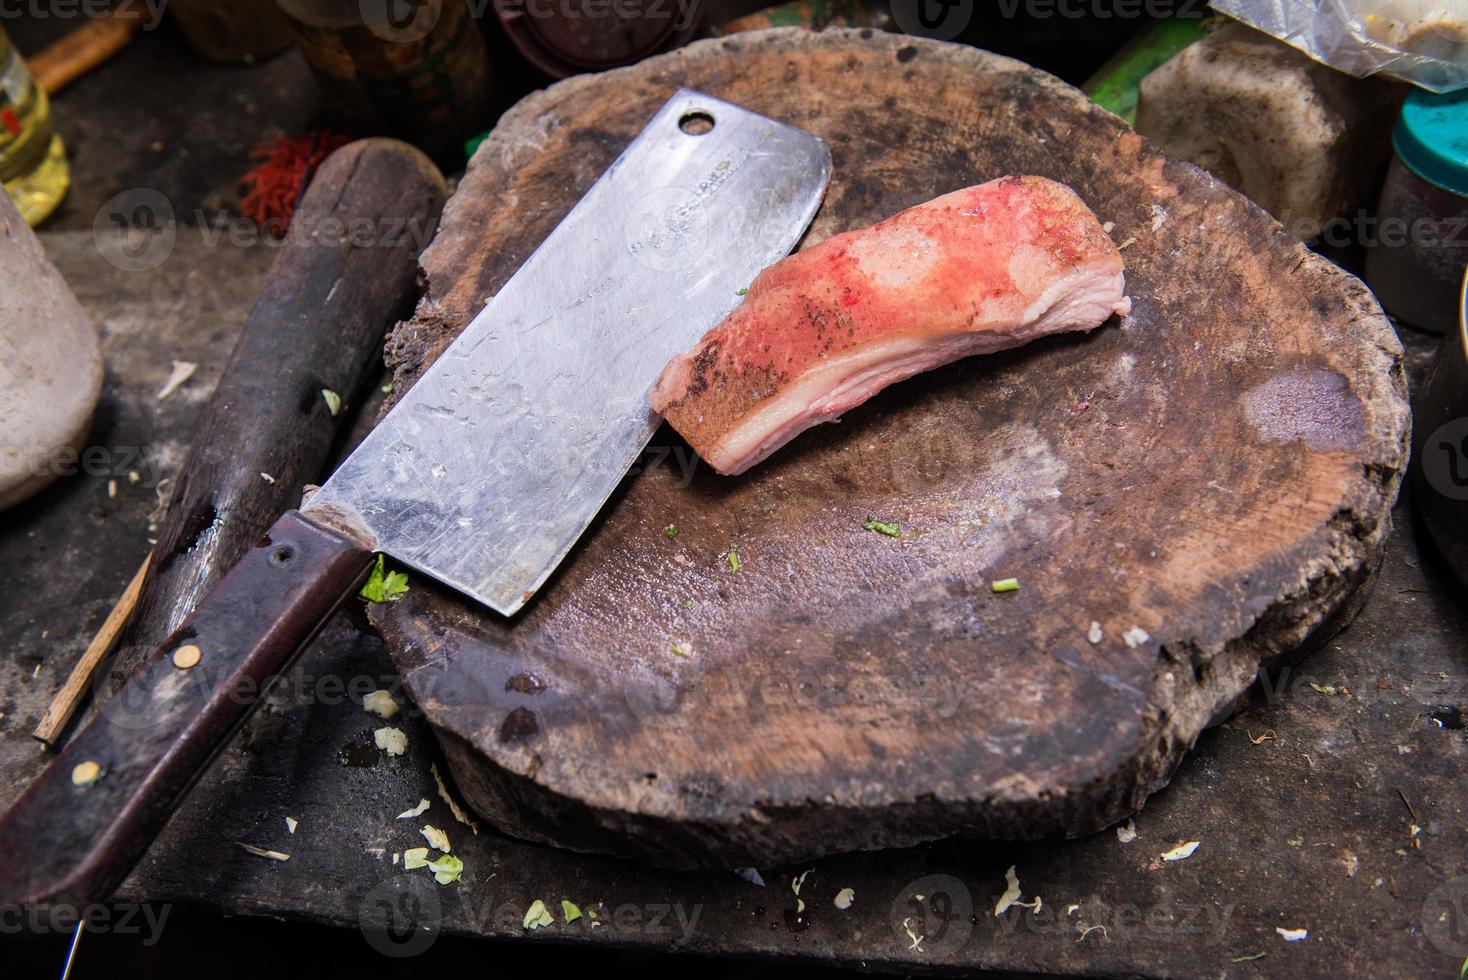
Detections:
[0, 9, 1468, 977]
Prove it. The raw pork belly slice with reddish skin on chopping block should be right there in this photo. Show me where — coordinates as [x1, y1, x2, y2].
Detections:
[650, 176, 1132, 474]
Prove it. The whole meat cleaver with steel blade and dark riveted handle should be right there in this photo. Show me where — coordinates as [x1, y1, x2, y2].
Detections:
[0, 89, 831, 905]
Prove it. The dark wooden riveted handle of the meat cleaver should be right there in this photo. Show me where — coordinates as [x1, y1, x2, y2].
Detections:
[0, 511, 371, 907]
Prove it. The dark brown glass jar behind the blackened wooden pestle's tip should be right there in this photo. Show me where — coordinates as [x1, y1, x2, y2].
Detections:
[267, 0, 495, 158]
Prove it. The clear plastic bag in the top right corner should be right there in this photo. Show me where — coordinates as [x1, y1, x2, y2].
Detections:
[1213, 0, 1468, 92]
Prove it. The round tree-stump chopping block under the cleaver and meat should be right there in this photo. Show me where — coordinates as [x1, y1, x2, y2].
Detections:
[367, 29, 1408, 867]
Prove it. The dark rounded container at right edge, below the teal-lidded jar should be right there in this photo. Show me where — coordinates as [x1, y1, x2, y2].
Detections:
[1412, 268, 1468, 588]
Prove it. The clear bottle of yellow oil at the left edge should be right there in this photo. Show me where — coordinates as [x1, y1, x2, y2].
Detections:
[0, 28, 72, 227]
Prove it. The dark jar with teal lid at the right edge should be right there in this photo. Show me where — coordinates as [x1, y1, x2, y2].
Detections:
[1365, 88, 1468, 333]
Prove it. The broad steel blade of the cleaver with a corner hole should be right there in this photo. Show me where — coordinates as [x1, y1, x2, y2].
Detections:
[302, 89, 831, 616]
